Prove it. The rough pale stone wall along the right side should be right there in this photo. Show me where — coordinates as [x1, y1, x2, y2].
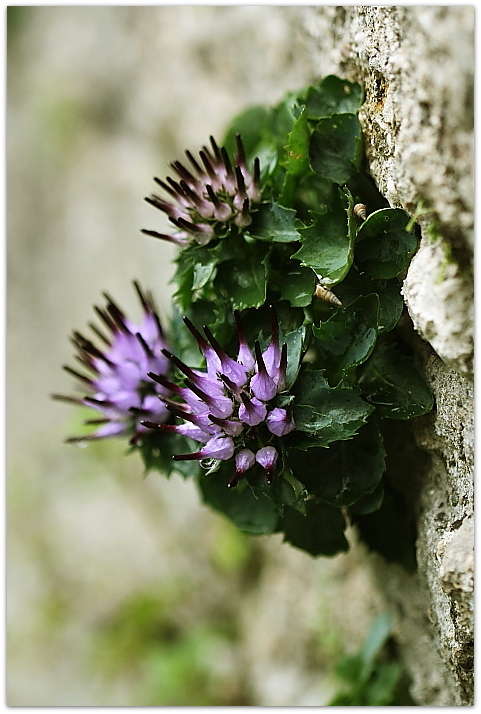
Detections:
[304, 6, 474, 706]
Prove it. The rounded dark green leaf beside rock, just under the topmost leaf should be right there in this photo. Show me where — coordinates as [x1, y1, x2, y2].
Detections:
[309, 114, 362, 184]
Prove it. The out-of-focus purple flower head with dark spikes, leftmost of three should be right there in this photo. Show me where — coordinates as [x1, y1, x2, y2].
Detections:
[53, 282, 170, 444]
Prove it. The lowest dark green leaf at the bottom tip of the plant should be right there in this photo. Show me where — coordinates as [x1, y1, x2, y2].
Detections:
[279, 501, 349, 556]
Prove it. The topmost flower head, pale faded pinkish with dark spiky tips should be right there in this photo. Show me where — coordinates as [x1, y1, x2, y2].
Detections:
[142, 134, 261, 247]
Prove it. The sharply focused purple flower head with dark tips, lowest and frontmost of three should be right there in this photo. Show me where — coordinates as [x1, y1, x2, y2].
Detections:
[143, 312, 295, 487]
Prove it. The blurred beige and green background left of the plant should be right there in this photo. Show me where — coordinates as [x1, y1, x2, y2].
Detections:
[7, 6, 402, 706]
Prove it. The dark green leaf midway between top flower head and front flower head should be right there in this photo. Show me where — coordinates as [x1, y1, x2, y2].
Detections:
[215, 251, 267, 310]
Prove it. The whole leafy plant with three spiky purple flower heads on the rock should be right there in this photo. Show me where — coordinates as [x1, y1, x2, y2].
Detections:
[56, 76, 432, 556]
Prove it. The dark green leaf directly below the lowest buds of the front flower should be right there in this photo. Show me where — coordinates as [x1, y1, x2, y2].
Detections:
[199, 462, 278, 535]
